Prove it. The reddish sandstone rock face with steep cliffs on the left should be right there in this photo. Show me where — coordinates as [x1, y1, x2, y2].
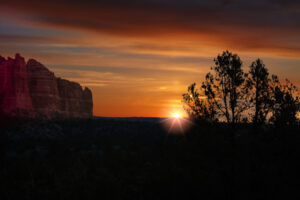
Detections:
[0, 54, 93, 119]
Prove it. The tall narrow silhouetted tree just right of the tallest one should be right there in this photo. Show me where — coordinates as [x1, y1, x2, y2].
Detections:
[247, 59, 270, 125]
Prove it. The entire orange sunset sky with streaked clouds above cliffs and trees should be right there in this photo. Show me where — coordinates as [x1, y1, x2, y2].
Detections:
[0, 0, 300, 117]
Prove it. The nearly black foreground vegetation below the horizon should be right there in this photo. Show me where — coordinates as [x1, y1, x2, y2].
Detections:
[0, 119, 300, 200]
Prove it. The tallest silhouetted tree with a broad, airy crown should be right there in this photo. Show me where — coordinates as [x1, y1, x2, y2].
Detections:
[202, 51, 248, 125]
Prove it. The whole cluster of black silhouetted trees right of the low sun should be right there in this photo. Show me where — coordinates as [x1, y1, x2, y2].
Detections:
[183, 51, 300, 126]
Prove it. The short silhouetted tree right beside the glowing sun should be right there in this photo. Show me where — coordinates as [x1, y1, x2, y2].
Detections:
[182, 83, 217, 123]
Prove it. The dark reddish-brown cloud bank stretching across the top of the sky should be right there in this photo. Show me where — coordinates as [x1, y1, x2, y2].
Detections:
[1, 0, 300, 56]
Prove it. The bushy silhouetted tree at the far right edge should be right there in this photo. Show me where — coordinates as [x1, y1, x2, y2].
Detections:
[270, 75, 300, 126]
